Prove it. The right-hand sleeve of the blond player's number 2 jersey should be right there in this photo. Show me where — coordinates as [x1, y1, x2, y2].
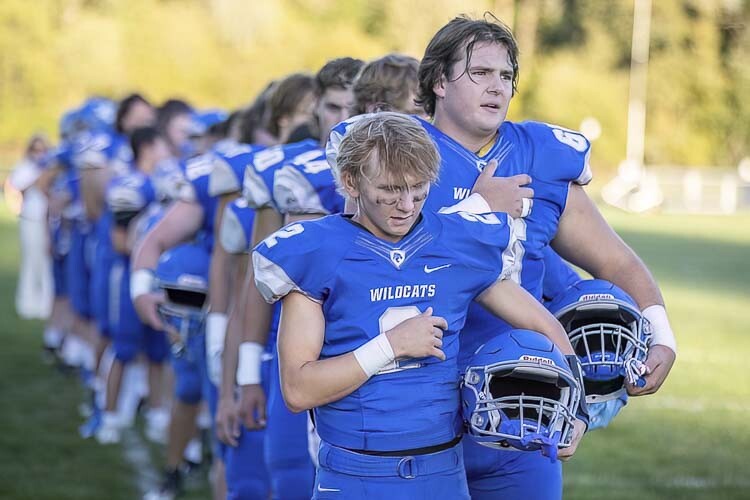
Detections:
[439, 212, 522, 295]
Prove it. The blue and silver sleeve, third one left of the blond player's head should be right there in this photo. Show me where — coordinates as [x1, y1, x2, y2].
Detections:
[208, 139, 265, 196]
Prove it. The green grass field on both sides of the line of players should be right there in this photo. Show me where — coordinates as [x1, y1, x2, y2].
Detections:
[0, 202, 750, 500]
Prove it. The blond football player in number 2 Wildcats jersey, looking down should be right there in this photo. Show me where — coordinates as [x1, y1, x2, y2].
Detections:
[253, 113, 573, 499]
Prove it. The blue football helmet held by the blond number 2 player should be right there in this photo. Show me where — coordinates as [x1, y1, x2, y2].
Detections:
[461, 330, 582, 461]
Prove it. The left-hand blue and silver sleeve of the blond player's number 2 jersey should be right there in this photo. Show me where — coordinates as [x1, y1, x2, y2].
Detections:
[253, 221, 335, 303]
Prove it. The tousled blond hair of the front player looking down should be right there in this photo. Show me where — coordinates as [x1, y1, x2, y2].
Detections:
[336, 112, 440, 194]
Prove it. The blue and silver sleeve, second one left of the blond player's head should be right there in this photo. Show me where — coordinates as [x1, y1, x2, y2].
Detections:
[242, 139, 318, 209]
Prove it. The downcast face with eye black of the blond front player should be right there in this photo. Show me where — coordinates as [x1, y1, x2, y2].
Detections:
[347, 164, 430, 242]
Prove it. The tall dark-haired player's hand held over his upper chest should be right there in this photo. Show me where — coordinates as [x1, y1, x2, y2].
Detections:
[471, 160, 534, 217]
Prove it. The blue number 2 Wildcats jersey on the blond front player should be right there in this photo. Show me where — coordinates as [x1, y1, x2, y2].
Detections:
[253, 212, 514, 451]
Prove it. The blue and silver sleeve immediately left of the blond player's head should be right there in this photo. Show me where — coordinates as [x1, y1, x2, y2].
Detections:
[273, 148, 344, 215]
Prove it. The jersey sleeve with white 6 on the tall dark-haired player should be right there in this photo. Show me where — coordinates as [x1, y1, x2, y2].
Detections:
[523, 122, 592, 186]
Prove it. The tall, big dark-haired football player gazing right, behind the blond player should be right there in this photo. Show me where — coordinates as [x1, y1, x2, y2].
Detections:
[418, 17, 676, 499]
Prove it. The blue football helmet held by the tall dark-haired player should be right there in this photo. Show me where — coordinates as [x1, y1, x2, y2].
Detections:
[547, 279, 651, 403]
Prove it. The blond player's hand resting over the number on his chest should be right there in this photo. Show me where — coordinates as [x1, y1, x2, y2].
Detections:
[385, 307, 448, 361]
